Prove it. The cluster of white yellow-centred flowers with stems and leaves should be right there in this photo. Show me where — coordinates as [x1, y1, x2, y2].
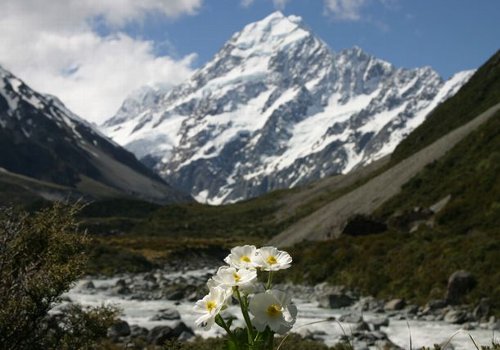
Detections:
[194, 245, 297, 349]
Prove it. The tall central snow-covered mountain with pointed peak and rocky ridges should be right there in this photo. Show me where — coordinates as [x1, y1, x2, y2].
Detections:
[103, 12, 472, 204]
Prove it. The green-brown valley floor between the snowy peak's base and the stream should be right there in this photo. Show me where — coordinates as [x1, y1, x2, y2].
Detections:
[79, 164, 394, 274]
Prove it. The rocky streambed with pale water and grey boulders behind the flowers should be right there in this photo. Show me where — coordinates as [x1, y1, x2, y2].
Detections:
[59, 266, 500, 350]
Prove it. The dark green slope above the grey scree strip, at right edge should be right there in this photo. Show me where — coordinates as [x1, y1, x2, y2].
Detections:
[391, 51, 500, 164]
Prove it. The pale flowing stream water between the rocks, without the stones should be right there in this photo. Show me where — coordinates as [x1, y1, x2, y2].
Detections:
[58, 269, 499, 350]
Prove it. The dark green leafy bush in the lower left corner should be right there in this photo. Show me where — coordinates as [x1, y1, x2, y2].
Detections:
[0, 205, 117, 349]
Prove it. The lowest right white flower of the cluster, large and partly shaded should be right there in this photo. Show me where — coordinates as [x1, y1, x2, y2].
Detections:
[249, 290, 297, 334]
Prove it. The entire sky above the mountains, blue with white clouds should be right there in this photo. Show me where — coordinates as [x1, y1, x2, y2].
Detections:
[0, 0, 500, 123]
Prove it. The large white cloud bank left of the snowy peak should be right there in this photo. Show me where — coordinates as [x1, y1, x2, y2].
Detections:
[0, 0, 202, 123]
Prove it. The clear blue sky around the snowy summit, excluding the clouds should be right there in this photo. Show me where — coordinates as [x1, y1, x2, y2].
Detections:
[130, 0, 500, 78]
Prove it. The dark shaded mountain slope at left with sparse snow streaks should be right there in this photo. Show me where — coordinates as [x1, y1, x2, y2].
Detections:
[0, 66, 189, 203]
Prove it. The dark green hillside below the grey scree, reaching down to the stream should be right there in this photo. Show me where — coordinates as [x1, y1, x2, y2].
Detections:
[284, 112, 500, 315]
